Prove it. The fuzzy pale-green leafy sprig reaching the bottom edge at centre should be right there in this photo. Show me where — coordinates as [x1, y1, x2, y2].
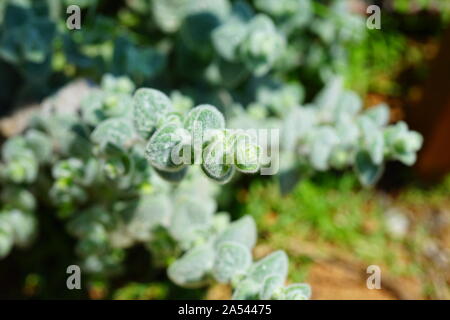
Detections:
[168, 216, 311, 300]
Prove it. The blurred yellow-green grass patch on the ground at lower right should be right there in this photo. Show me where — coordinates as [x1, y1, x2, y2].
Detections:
[241, 174, 450, 281]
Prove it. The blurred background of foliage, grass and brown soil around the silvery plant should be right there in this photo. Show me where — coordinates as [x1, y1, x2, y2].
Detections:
[0, 0, 450, 299]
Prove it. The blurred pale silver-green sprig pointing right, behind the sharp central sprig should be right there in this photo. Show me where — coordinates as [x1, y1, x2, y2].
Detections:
[229, 76, 423, 191]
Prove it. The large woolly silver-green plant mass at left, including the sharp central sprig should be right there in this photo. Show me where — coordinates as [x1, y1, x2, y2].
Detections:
[0, 76, 311, 299]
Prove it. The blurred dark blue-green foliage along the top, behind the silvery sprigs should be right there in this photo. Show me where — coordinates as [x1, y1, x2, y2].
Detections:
[0, 0, 370, 113]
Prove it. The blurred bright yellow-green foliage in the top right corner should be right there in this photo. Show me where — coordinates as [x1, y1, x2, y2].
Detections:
[346, 0, 450, 98]
